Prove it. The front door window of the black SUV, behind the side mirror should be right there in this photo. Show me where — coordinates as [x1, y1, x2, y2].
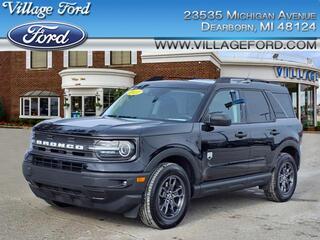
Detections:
[208, 90, 243, 123]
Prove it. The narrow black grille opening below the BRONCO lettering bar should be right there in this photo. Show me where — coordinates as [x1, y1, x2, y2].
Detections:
[32, 156, 85, 172]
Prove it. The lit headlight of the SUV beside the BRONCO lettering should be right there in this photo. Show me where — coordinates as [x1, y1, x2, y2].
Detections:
[93, 140, 136, 160]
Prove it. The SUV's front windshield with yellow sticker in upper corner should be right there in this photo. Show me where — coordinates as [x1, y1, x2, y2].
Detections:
[103, 87, 204, 121]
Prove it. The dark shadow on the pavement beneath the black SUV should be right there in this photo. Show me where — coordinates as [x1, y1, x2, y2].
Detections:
[43, 188, 267, 228]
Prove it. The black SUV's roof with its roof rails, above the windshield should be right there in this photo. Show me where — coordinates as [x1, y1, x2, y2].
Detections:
[137, 77, 288, 93]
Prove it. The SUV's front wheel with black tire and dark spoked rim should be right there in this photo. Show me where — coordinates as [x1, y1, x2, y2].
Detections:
[139, 163, 191, 229]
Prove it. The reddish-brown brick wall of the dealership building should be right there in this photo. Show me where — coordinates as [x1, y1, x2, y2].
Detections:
[0, 51, 220, 119]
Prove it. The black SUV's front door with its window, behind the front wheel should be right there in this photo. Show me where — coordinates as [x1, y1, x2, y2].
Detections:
[201, 89, 250, 181]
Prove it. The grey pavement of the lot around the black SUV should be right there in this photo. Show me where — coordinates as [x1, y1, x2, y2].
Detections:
[0, 129, 320, 240]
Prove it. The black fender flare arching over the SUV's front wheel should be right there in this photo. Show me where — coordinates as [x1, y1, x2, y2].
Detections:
[145, 146, 201, 184]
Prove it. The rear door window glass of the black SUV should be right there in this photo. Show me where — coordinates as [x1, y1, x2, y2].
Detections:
[243, 90, 271, 123]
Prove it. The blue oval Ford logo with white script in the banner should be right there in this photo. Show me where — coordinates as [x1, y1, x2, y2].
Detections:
[8, 22, 87, 50]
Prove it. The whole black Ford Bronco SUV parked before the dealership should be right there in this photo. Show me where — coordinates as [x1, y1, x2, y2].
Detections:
[23, 78, 302, 228]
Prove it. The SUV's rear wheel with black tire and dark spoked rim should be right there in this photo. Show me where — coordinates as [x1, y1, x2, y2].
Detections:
[264, 153, 297, 202]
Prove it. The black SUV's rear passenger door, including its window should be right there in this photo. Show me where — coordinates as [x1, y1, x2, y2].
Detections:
[241, 89, 279, 174]
